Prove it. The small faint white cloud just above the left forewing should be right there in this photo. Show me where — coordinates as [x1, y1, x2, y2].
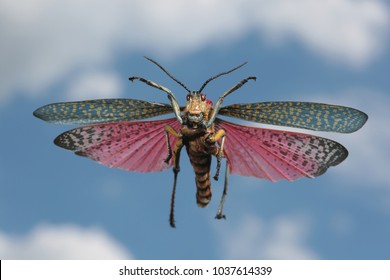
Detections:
[67, 72, 121, 101]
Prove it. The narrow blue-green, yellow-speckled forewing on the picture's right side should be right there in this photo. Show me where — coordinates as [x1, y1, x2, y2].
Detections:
[219, 101, 368, 133]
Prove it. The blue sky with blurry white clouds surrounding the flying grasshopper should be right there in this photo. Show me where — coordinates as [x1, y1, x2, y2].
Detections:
[0, 0, 390, 259]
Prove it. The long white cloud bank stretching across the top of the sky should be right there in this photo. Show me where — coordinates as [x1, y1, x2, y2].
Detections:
[0, 0, 389, 103]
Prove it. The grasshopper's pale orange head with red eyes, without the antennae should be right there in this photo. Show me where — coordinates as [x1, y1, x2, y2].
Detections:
[183, 91, 213, 128]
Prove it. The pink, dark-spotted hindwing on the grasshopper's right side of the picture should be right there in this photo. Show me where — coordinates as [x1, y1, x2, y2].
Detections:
[215, 119, 348, 181]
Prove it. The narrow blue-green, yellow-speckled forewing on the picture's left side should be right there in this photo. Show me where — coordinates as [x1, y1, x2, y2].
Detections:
[33, 99, 173, 124]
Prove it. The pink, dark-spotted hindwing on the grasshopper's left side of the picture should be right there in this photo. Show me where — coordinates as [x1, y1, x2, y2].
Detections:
[54, 118, 179, 172]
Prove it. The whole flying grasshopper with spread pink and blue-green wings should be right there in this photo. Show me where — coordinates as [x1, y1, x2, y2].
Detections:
[34, 58, 368, 227]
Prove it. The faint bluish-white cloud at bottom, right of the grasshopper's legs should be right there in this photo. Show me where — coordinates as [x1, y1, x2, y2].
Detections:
[217, 215, 318, 259]
